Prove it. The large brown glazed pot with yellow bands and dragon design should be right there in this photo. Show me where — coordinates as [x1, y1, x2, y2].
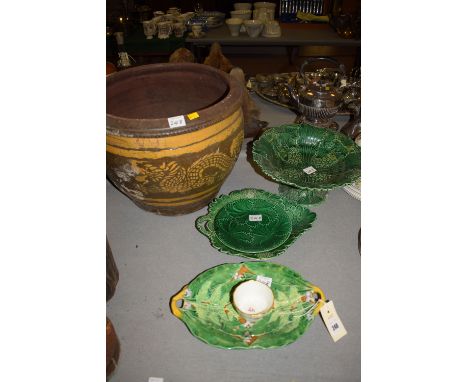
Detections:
[106, 63, 244, 215]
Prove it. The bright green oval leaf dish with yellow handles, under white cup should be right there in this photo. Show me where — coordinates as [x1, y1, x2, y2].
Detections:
[171, 262, 325, 349]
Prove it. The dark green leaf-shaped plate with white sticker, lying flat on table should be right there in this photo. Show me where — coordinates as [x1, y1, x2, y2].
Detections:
[196, 188, 316, 259]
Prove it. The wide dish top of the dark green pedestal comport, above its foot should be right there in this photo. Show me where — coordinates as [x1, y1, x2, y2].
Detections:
[253, 124, 361, 190]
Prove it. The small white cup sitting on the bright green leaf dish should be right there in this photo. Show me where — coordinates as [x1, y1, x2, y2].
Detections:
[232, 280, 275, 322]
